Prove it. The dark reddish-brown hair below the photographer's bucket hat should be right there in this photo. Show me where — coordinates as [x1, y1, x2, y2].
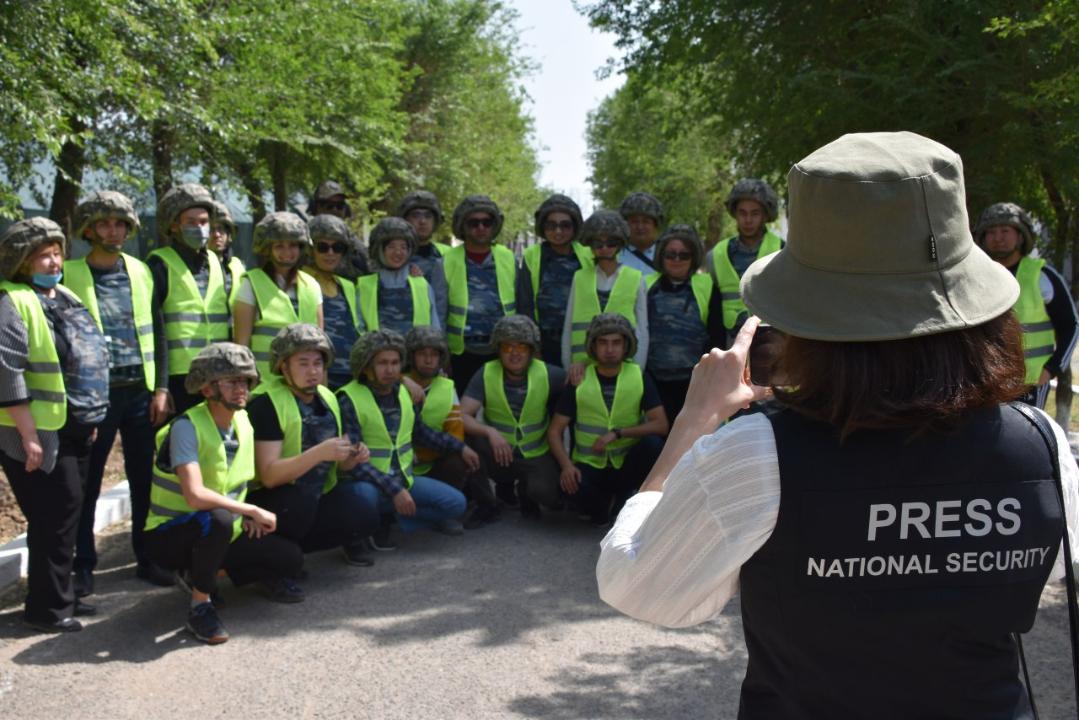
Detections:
[776, 310, 1026, 438]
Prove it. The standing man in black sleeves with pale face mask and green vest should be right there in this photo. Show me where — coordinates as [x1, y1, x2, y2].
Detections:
[146, 182, 229, 412]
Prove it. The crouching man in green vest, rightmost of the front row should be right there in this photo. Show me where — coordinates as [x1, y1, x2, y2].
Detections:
[547, 313, 669, 527]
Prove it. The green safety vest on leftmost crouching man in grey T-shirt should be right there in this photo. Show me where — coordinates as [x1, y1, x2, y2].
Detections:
[146, 402, 255, 540]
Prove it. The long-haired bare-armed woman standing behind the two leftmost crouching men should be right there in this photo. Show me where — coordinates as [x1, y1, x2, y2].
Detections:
[232, 213, 323, 376]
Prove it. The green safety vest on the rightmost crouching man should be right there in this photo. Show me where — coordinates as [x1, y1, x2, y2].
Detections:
[573, 363, 644, 470]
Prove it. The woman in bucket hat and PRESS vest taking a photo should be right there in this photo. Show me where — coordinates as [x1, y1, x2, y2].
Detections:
[597, 133, 1079, 719]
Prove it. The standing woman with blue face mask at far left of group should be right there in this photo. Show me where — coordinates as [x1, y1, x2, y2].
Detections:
[0, 218, 109, 633]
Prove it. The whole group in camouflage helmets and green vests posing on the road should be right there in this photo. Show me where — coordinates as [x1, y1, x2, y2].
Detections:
[0, 179, 1076, 643]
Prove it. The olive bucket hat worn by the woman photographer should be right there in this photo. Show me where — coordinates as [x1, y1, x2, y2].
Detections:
[741, 133, 1019, 342]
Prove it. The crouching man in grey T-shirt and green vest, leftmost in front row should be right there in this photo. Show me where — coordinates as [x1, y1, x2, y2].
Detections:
[145, 342, 303, 644]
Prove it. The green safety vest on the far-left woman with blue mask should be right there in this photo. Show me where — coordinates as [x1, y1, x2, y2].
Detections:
[0, 281, 67, 430]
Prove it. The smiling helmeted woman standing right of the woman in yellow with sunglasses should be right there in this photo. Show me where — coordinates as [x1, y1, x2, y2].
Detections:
[356, 217, 441, 335]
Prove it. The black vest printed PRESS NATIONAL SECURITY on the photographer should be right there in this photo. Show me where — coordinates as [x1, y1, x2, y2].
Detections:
[738, 406, 1064, 720]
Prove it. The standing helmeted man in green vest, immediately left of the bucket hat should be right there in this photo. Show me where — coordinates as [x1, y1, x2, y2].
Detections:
[705, 177, 783, 347]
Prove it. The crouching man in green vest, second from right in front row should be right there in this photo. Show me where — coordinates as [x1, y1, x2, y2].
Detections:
[461, 315, 565, 518]
